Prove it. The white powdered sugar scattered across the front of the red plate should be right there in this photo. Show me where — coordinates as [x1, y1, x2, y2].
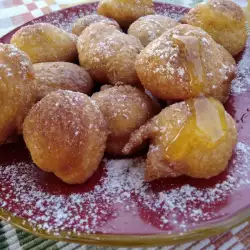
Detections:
[0, 142, 250, 235]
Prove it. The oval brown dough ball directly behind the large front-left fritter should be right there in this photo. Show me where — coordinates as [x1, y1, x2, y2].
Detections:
[33, 62, 94, 100]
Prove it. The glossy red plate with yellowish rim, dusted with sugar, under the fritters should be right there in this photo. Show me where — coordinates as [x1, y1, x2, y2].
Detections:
[0, 0, 250, 246]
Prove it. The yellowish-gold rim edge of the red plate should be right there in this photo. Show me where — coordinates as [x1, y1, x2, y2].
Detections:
[0, 0, 250, 247]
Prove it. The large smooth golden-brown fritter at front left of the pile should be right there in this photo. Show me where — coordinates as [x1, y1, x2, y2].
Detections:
[23, 90, 108, 184]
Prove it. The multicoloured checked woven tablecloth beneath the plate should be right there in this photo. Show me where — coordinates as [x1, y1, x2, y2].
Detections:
[0, 0, 250, 250]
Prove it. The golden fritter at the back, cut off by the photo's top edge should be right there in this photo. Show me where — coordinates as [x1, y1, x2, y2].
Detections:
[97, 0, 155, 28]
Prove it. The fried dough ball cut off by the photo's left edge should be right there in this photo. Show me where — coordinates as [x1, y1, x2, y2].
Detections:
[0, 43, 35, 144]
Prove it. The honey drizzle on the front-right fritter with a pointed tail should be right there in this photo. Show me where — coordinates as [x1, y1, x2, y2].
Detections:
[165, 97, 227, 161]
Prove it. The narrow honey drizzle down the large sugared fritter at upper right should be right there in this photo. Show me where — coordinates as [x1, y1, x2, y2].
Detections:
[173, 35, 206, 96]
